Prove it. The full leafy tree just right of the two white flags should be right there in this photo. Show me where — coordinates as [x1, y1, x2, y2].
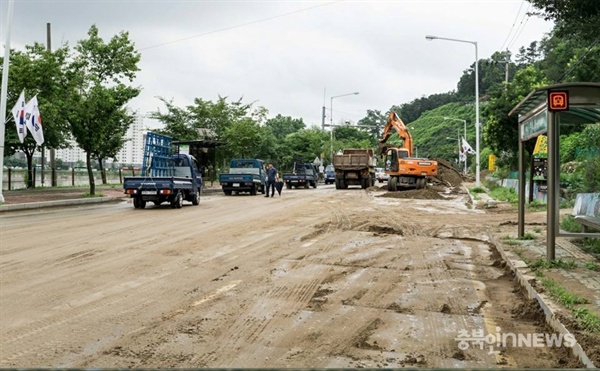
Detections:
[67, 25, 140, 195]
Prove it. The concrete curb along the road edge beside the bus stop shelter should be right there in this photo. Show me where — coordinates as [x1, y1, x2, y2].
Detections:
[490, 236, 596, 368]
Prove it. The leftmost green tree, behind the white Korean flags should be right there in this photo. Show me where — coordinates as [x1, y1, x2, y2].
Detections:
[0, 43, 69, 188]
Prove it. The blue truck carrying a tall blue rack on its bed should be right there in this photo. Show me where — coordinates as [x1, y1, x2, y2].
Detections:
[123, 132, 202, 209]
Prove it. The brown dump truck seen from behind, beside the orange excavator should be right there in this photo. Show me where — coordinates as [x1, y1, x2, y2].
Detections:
[333, 148, 376, 189]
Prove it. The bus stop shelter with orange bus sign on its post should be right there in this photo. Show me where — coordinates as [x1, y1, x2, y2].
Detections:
[509, 82, 600, 260]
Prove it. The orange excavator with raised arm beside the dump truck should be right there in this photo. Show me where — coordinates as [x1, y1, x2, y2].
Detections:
[379, 111, 438, 192]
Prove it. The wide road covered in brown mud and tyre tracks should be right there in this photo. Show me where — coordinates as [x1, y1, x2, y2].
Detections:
[0, 185, 569, 368]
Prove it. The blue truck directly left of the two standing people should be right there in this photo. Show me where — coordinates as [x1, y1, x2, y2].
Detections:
[219, 158, 266, 196]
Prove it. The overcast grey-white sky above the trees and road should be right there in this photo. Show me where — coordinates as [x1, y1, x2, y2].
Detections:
[0, 0, 552, 126]
